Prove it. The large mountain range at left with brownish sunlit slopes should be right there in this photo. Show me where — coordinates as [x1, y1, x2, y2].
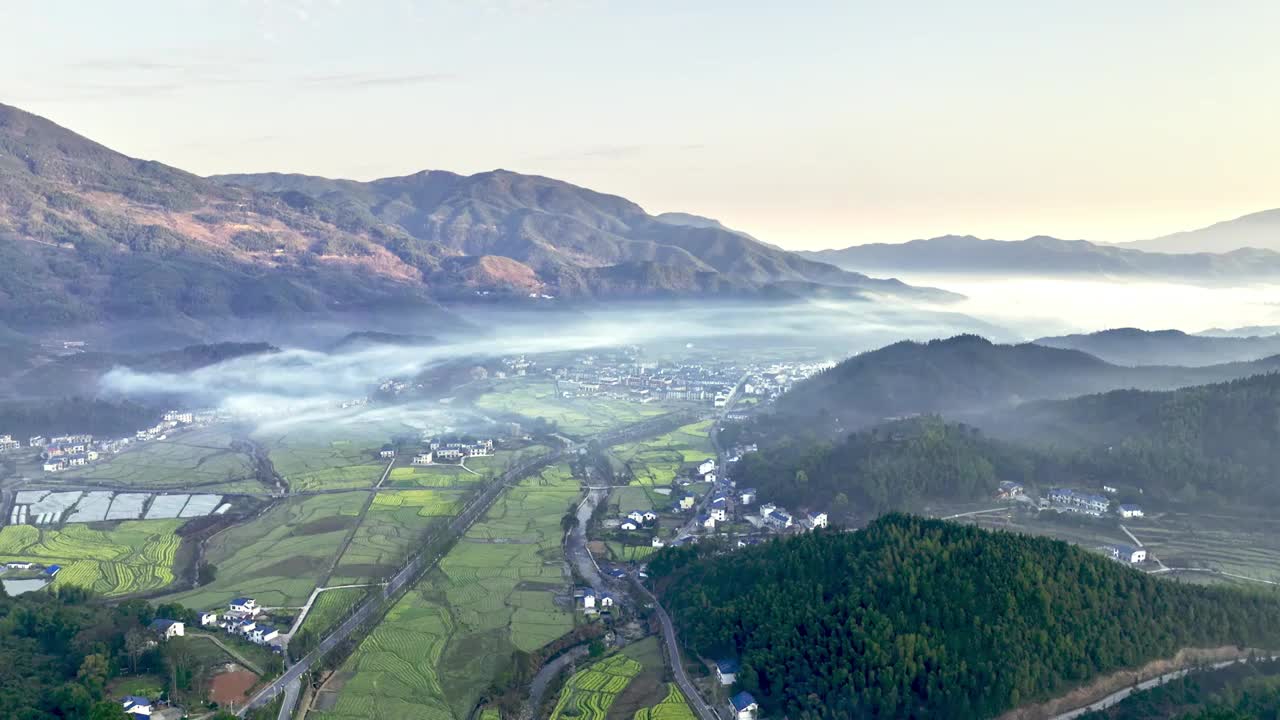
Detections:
[0, 105, 959, 329]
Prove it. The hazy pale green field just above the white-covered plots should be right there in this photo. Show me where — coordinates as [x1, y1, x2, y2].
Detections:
[58, 428, 262, 493]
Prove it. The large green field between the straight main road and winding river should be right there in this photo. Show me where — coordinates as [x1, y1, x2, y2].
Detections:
[320, 465, 580, 720]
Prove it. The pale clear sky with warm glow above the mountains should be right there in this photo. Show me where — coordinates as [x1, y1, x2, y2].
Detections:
[0, 0, 1280, 249]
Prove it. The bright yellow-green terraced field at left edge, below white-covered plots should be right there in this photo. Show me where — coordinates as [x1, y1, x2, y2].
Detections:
[0, 520, 182, 596]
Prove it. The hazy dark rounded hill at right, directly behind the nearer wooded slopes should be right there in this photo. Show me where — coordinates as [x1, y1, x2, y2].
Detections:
[777, 336, 1280, 430]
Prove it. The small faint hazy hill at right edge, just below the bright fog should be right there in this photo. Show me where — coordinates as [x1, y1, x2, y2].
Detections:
[1036, 328, 1280, 366]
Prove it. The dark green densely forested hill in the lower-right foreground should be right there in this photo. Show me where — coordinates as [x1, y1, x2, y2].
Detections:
[649, 515, 1280, 719]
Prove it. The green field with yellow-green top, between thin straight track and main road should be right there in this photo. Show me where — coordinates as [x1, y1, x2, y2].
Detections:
[330, 489, 467, 584]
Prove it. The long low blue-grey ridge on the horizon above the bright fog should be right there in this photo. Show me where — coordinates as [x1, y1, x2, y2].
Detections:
[804, 234, 1280, 284]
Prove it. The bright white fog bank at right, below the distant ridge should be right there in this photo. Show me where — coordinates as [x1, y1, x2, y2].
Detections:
[900, 274, 1280, 340]
